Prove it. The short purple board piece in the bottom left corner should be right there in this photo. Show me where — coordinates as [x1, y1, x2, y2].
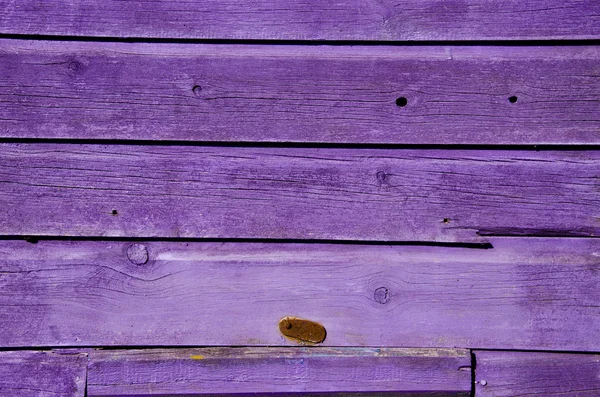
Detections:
[0, 350, 87, 397]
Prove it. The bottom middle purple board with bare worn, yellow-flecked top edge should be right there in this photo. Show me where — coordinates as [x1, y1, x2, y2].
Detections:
[88, 348, 471, 397]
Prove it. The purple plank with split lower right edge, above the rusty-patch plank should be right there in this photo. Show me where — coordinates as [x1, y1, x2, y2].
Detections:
[0, 143, 600, 242]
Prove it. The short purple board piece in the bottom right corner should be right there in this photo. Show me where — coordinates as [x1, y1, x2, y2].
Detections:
[475, 351, 600, 397]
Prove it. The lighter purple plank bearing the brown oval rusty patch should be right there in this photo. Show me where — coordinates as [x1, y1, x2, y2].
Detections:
[0, 237, 600, 351]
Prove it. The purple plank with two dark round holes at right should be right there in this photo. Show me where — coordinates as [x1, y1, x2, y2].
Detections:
[0, 39, 600, 144]
